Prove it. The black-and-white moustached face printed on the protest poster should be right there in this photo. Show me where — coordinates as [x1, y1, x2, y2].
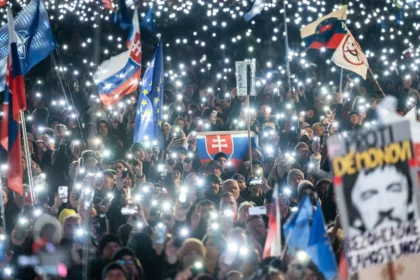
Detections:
[349, 162, 414, 234]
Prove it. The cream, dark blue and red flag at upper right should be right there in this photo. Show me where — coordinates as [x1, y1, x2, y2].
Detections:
[300, 6, 347, 49]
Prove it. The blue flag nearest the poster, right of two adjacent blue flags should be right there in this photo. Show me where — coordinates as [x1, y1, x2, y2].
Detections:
[305, 200, 338, 280]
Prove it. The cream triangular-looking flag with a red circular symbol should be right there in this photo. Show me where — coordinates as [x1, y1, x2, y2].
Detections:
[331, 30, 369, 80]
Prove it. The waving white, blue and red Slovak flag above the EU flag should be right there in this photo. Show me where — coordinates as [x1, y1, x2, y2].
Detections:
[93, 10, 142, 107]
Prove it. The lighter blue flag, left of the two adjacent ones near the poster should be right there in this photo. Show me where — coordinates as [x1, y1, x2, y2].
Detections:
[283, 196, 313, 250]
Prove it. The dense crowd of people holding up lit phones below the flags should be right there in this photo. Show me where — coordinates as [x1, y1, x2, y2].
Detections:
[1, 61, 415, 280]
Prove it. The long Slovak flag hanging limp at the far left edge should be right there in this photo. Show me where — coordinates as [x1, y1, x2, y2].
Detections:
[0, 8, 26, 195]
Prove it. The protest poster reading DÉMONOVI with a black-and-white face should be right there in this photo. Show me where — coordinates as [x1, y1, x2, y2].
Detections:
[328, 121, 420, 279]
